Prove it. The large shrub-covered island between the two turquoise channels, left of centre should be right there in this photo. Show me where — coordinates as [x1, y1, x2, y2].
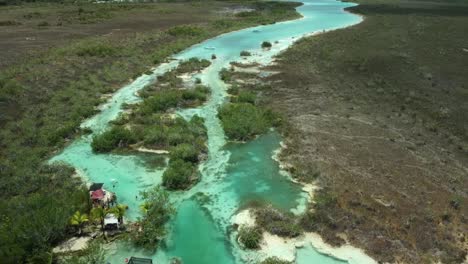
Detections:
[91, 58, 211, 190]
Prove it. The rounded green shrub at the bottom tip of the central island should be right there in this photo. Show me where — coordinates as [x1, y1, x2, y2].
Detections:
[162, 159, 196, 190]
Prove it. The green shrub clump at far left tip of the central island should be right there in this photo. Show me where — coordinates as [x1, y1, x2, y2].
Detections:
[91, 126, 136, 152]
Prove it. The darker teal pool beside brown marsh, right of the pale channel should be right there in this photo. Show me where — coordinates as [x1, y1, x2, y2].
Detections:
[224, 132, 305, 210]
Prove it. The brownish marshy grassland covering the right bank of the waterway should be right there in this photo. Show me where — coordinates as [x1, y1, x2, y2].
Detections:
[256, 0, 468, 263]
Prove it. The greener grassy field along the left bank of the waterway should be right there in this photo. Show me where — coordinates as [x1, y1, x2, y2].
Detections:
[0, 1, 298, 263]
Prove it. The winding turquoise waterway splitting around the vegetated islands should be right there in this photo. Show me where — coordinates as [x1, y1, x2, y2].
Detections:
[52, 0, 361, 264]
